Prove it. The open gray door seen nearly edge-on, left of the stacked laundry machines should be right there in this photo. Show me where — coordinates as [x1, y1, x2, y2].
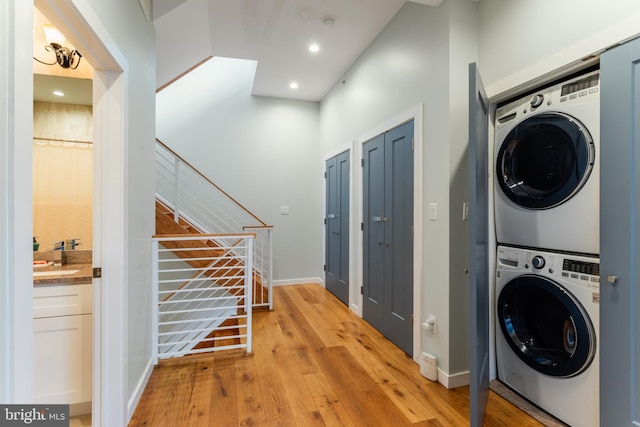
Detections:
[469, 63, 490, 426]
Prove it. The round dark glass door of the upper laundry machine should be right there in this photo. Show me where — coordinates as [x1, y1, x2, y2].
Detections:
[496, 112, 595, 209]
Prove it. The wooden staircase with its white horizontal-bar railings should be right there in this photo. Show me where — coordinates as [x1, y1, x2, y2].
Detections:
[153, 141, 272, 363]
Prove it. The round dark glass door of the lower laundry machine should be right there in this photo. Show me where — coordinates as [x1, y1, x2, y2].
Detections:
[498, 275, 596, 377]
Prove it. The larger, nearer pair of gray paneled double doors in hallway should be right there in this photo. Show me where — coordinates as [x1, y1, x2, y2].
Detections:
[363, 121, 413, 355]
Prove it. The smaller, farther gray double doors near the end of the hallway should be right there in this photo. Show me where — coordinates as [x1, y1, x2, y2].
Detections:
[325, 151, 350, 305]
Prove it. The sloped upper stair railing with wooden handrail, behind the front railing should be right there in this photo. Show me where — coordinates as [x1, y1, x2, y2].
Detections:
[156, 139, 273, 310]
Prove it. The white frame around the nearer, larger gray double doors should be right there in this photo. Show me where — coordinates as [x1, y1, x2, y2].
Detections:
[349, 103, 423, 362]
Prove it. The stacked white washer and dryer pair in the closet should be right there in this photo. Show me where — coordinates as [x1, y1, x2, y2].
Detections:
[495, 70, 600, 427]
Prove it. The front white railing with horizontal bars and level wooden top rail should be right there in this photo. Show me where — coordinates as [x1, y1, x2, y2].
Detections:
[152, 233, 255, 365]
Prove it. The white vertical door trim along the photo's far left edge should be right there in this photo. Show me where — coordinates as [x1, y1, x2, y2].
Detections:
[0, 0, 33, 403]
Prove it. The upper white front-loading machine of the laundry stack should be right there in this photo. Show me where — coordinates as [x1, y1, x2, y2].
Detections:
[494, 71, 600, 255]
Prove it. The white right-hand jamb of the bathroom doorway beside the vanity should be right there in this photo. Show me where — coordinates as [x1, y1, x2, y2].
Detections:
[93, 68, 128, 425]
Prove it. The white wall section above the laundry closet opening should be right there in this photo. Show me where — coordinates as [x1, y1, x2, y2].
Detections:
[478, 0, 640, 97]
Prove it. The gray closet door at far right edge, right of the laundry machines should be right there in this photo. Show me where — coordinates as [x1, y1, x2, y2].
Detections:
[599, 36, 640, 426]
